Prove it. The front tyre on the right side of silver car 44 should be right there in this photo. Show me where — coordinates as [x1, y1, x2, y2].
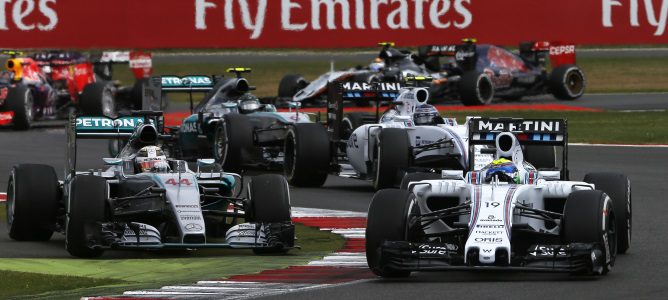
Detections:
[246, 174, 291, 254]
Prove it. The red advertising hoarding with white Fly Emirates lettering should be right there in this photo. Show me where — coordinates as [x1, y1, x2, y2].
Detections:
[0, 0, 668, 49]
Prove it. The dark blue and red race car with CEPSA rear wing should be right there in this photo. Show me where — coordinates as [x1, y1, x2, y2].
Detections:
[419, 39, 586, 105]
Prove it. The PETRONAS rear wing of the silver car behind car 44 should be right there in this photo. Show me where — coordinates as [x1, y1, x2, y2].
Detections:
[142, 75, 218, 111]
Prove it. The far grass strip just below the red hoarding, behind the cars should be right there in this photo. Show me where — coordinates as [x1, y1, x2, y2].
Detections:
[114, 56, 668, 96]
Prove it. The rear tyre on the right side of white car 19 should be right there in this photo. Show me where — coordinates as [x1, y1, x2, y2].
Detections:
[583, 173, 632, 254]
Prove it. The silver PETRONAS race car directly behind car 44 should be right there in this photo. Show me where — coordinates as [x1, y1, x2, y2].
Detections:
[140, 68, 311, 172]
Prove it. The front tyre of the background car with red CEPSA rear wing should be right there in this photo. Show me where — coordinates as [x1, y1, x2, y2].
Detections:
[459, 71, 494, 106]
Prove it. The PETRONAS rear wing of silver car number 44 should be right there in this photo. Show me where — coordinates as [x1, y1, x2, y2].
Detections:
[65, 111, 164, 176]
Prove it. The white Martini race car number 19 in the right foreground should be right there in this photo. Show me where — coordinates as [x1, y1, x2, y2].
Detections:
[366, 118, 631, 277]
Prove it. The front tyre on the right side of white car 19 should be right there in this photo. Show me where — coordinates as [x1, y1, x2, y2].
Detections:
[561, 191, 618, 275]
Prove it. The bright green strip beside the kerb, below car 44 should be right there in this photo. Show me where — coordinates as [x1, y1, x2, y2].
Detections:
[0, 204, 345, 299]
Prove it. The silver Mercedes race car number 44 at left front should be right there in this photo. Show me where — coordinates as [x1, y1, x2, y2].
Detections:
[7, 112, 294, 258]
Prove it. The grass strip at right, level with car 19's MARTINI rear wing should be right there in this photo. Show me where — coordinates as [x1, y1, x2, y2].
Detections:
[443, 111, 668, 144]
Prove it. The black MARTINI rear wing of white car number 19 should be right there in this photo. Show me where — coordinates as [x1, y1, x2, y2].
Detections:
[468, 118, 568, 179]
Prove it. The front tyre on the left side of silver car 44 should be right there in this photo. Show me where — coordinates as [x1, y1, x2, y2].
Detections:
[65, 175, 107, 258]
